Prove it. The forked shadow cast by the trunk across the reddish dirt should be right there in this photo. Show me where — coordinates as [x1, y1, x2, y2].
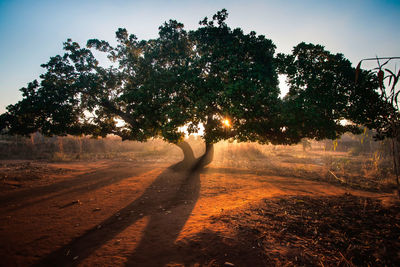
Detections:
[34, 162, 203, 266]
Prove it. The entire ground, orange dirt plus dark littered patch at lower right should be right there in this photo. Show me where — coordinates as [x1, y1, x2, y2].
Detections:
[0, 144, 400, 266]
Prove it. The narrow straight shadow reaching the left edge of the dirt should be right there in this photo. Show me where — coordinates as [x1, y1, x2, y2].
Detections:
[0, 163, 147, 212]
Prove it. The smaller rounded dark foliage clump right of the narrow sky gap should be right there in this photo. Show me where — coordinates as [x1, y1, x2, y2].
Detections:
[277, 43, 387, 140]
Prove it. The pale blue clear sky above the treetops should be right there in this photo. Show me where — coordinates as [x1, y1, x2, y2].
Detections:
[0, 0, 400, 114]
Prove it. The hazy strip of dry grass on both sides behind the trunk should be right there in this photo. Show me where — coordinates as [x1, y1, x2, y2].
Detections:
[0, 134, 395, 192]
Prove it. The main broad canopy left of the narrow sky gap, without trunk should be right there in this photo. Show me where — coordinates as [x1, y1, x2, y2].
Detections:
[2, 10, 281, 146]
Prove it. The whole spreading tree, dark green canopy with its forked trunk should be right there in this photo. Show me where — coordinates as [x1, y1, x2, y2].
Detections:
[0, 10, 386, 170]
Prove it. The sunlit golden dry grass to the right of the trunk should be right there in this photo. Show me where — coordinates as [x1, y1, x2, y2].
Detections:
[214, 142, 395, 195]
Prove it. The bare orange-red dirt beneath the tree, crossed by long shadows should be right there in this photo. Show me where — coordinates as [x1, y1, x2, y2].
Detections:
[0, 161, 390, 266]
